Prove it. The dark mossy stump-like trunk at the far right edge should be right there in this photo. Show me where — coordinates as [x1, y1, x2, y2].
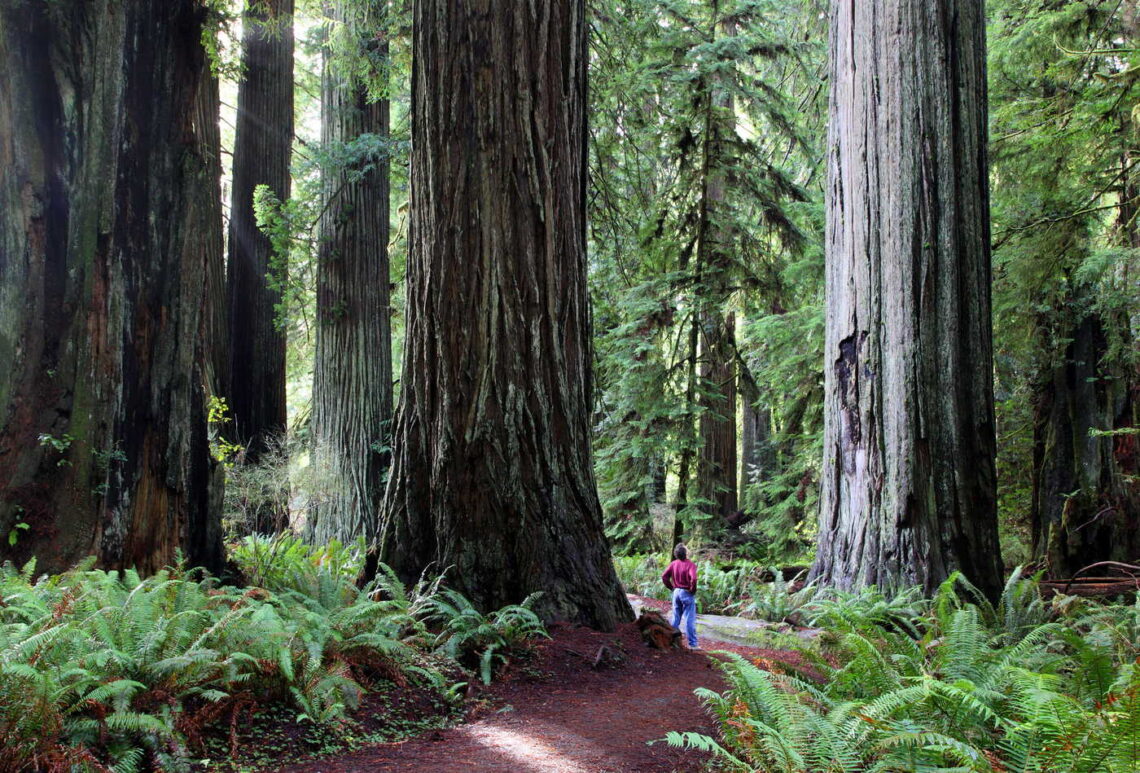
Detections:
[1032, 307, 1140, 577]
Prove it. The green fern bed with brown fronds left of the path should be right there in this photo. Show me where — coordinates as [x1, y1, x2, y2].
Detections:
[0, 536, 545, 772]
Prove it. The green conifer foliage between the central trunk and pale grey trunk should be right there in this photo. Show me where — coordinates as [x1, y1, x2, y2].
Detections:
[588, 0, 823, 551]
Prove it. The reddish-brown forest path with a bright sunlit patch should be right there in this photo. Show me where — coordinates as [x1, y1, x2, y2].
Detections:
[253, 597, 811, 773]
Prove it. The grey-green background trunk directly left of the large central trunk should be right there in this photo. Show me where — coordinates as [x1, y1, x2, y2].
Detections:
[306, 0, 392, 544]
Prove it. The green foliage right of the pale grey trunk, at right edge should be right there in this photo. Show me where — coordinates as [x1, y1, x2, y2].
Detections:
[987, 0, 1140, 547]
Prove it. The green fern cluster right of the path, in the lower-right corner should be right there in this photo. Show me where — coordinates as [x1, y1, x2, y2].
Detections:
[667, 572, 1140, 773]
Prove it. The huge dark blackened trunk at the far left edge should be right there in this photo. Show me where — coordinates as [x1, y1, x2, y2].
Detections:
[0, 0, 221, 571]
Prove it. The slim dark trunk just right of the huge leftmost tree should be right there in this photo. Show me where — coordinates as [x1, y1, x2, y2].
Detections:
[226, 0, 293, 532]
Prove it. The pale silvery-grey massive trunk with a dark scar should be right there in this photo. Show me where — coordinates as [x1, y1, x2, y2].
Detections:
[812, 0, 1001, 593]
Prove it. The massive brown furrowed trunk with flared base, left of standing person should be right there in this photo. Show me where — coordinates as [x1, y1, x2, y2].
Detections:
[382, 0, 633, 629]
